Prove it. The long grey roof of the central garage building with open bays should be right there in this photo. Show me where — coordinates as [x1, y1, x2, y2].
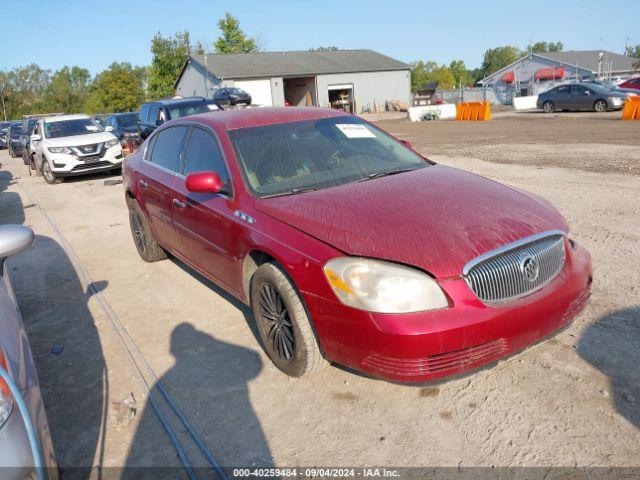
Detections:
[175, 50, 411, 85]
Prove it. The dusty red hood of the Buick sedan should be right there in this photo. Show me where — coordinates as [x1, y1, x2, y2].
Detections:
[256, 165, 567, 278]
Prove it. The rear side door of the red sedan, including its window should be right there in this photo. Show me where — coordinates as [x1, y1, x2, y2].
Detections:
[138, 126, 189, 250]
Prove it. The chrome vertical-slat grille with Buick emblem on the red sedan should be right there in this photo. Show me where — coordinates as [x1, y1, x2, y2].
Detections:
[464, 231, 566, 303]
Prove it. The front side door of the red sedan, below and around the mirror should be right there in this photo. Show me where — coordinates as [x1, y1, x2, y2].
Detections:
[172, 127, 239, 290]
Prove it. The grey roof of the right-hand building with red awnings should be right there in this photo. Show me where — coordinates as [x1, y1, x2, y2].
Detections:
[479, 50, 640, 84]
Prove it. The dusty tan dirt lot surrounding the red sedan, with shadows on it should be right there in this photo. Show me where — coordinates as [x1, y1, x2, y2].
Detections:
[0, 113, 640, 476]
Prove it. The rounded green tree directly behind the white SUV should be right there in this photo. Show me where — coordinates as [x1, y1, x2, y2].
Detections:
[43, 66, 91, 113]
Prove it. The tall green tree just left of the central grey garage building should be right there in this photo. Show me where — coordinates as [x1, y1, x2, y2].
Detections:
[147, 31, 192, 100]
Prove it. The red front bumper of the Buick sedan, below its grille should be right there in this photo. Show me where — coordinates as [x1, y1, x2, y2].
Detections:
[303, 243, 592, 382]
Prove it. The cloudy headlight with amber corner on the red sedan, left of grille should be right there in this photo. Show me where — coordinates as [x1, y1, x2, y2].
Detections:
[324, 257, 449, 313]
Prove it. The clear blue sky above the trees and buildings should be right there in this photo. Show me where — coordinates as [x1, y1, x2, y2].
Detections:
[0, 0, 640, 74]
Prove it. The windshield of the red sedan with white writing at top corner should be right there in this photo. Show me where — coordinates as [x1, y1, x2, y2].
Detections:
[228, 116, 429, 197]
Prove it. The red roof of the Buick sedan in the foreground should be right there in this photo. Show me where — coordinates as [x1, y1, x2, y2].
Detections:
[178, 107, 350, 130]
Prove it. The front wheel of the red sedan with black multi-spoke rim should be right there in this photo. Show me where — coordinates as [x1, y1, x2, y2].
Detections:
[251, 262, 328, 377]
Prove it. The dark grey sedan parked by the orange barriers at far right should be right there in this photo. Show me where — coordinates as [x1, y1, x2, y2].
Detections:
[537, 83, 626, 113]
